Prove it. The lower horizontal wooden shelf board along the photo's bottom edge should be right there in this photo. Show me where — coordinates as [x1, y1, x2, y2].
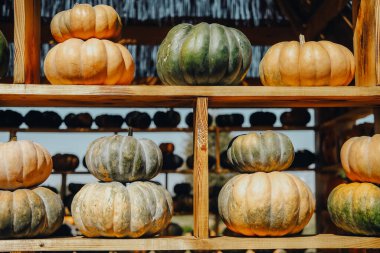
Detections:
[0, 234, 380, 251]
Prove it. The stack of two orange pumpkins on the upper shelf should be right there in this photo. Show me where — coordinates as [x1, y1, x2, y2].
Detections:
[44, 4, 135, 85]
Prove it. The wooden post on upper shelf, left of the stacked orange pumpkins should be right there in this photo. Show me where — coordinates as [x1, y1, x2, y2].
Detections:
[13, 0, 41, 83]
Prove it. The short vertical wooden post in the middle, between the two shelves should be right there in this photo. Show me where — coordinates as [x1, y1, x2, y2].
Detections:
[193, 97, 209, 239]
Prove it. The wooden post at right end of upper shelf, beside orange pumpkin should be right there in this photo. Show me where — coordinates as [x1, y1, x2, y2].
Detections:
[353, 0, 380, 86]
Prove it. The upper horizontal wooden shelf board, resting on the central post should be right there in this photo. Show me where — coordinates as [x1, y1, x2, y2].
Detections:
[0, 84, 380, 108]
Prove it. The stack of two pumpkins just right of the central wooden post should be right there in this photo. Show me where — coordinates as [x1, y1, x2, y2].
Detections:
[218, 131, 315, 236]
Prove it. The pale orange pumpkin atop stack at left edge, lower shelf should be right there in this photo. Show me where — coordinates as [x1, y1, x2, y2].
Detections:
[0, 140, 53, 190]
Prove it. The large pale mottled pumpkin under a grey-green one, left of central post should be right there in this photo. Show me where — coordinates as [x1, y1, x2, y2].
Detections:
[71, 182, 173, 238]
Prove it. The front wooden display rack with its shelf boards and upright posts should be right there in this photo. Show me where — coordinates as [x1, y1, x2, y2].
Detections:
[0, 0, 380, 251]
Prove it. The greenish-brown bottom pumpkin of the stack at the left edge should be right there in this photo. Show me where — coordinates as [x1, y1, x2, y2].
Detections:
[0, 187, 64, 238]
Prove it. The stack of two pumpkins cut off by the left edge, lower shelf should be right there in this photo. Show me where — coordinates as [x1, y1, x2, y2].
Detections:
[0, 136, 64, 238]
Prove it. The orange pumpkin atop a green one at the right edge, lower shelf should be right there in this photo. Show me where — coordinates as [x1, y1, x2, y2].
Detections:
[340, 134, 380, 184]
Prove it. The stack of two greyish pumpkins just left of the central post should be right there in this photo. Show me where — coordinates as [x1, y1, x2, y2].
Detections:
[71, 130, 173, 238]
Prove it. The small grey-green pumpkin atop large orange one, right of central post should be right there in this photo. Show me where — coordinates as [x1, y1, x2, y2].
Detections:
[227, 131, 294, 173]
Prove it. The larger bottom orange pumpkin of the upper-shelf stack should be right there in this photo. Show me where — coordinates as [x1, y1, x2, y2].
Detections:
[44, 38, 135, 85]
